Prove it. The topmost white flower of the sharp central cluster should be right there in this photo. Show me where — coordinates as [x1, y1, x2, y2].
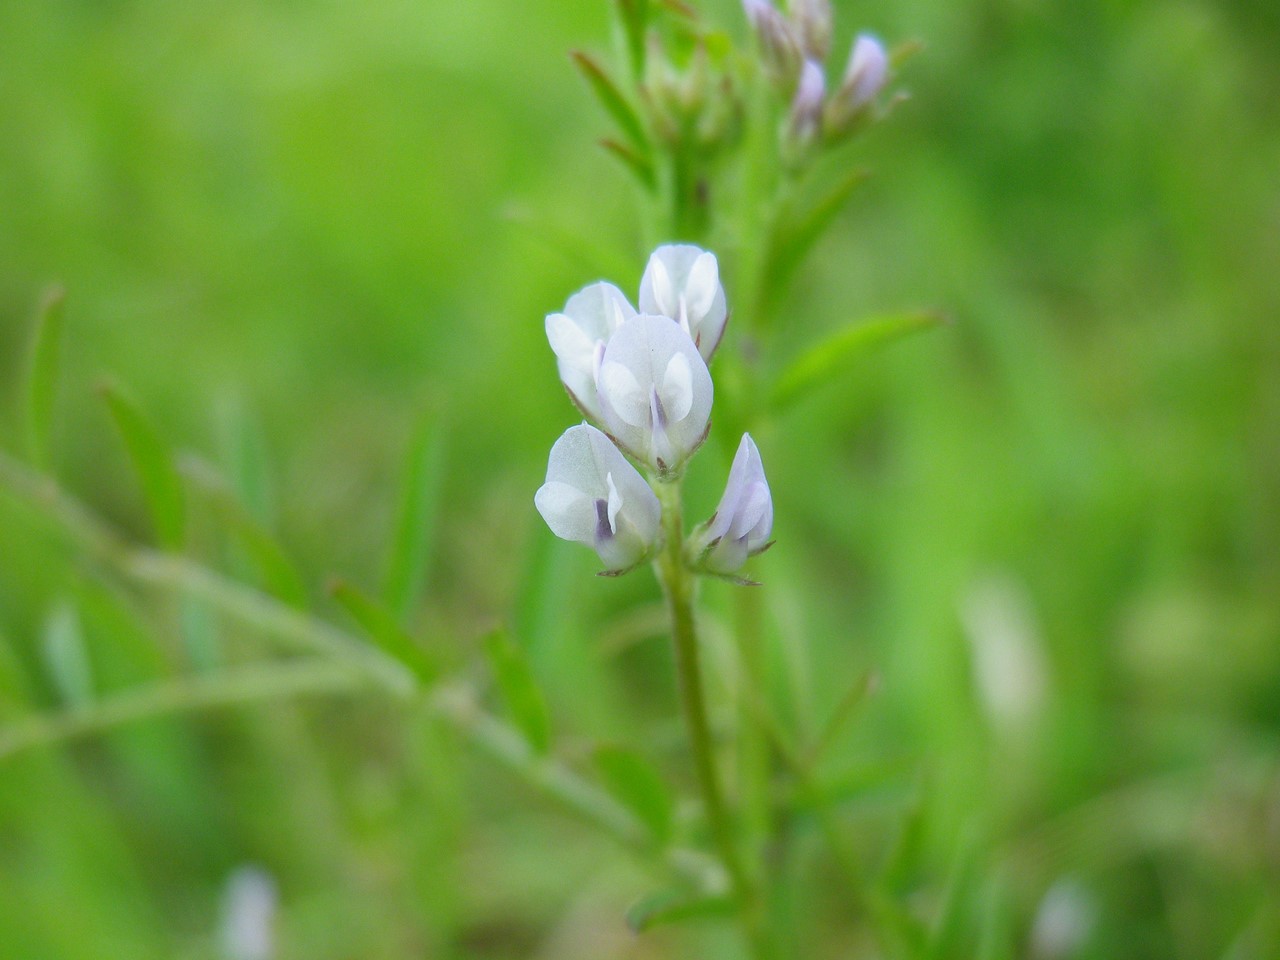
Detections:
[640, 243, 728, 361]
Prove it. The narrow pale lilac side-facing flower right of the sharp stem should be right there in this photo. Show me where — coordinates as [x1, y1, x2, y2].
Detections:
[690, 434, 773, 573]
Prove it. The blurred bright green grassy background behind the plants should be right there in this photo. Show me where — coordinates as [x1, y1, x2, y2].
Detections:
[0, 0, 1280, 960]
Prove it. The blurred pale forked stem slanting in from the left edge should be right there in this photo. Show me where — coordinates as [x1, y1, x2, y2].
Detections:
[0, 453, 719, 886]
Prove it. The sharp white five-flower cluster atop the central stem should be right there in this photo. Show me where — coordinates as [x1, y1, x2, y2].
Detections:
[534, 244, 773, 576]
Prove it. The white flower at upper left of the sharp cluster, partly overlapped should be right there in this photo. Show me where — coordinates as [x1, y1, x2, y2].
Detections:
[547, 283, 636, 420]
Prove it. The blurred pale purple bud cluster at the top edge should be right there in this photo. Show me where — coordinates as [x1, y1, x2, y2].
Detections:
[742, 0, 890, 148]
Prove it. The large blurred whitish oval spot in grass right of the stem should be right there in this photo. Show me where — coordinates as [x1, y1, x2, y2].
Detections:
[960, 576, 1048, 732]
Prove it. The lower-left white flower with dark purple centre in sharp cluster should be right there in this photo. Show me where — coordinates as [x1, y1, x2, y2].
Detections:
[534, 424, 662, 573]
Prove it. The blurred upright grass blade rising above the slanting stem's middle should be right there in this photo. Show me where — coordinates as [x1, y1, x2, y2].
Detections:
[383, 416, 444, 623]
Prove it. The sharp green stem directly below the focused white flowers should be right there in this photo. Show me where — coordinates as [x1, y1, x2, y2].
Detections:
[654, 480, 771, 957]
